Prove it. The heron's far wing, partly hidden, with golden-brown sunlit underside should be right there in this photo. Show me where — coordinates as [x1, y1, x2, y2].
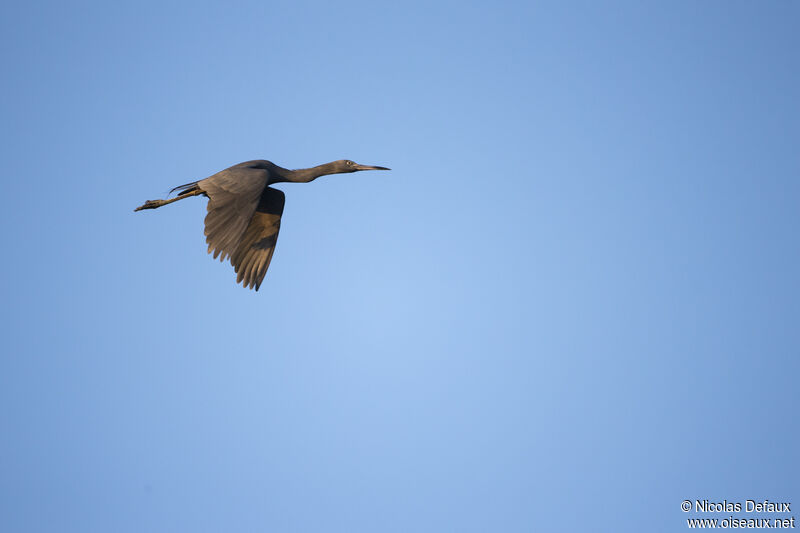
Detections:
[231, 187, 286, 290]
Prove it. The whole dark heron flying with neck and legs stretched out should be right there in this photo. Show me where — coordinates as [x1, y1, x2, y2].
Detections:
[134, 159, 390, 290]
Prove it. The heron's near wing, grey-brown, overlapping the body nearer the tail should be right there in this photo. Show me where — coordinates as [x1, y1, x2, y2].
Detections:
[197, 162, 269, 261]
